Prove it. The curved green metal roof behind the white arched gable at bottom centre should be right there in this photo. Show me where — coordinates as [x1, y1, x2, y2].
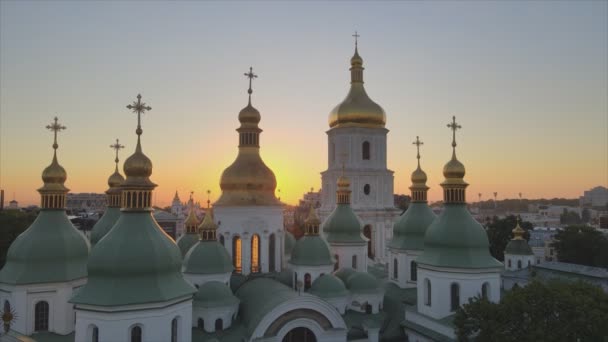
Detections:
[236, 278, 298, 336]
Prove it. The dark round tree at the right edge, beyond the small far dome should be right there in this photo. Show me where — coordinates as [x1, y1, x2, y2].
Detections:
[553, 225, 608, 267]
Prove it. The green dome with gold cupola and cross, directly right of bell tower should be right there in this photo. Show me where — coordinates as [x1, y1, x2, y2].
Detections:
[388, 137, 437, 250]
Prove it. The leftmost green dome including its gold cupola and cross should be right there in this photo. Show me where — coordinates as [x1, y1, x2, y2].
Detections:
[0, 118, 89, 285]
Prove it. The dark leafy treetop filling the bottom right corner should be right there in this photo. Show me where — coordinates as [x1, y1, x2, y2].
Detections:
[454, 280, 608, 342]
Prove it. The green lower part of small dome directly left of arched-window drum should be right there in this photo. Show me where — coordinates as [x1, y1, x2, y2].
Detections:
[183, 240, 234, 274]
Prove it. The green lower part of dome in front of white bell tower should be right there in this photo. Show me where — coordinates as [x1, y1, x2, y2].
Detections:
[323, 204, 367, 244]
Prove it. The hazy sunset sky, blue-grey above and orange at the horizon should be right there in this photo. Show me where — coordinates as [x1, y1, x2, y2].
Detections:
[0, 1, 608, 206]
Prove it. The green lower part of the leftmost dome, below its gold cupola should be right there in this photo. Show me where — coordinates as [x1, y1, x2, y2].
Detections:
[0, 209, 89, 285]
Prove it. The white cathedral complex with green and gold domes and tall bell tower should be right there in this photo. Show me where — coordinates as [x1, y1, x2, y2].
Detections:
[0, 38, 530, 342]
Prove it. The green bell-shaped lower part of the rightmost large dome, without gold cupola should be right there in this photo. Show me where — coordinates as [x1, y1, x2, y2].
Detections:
[417, 204, 503, 268]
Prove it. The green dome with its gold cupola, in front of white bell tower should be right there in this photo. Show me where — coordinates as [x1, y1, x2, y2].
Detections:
[323, 175, 367, 244]
